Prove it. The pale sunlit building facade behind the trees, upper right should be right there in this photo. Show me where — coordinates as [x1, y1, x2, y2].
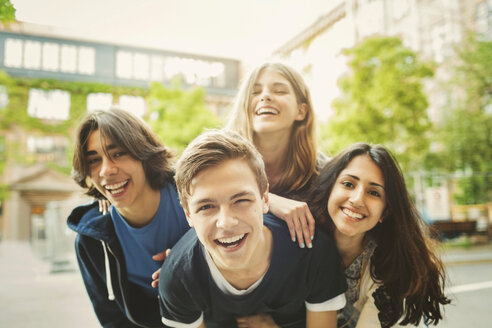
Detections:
[275, 0, 492, 121]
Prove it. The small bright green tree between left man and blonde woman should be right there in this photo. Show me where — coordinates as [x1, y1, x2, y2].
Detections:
[149, 83, 222, 152]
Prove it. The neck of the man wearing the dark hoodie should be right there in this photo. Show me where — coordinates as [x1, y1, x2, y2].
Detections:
[117, 187, 161, 228]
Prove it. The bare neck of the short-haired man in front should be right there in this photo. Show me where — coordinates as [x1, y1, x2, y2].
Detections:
[218, 226, 273, 290]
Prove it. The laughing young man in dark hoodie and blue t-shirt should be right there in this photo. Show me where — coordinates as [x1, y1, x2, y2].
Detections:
[67, 109, 189, 327]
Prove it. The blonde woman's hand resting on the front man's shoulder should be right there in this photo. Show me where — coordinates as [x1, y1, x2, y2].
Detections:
[268, 193, 315, 248]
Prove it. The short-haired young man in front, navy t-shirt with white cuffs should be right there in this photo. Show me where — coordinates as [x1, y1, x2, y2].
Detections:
[159, 131, 346, 328]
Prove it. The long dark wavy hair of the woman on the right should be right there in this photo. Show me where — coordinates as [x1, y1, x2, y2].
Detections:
[310, 143, 450, 325]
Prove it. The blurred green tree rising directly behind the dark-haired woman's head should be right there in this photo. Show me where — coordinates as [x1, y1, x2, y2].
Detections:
[321, 37, 433, 169]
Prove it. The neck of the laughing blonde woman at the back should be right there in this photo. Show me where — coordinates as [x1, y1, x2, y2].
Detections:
[253, 133, 290, 187]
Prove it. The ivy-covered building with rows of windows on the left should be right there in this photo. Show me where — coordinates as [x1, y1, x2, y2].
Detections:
[0, 23, 240, 243]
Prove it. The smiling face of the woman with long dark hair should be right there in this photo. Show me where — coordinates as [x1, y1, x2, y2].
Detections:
[327, 155, 386, 237]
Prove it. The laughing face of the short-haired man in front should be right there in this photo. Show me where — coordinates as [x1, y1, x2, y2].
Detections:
[186, 159, 268, 271]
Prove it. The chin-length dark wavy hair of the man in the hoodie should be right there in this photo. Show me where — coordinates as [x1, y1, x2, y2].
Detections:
[72, 109, 174, 198]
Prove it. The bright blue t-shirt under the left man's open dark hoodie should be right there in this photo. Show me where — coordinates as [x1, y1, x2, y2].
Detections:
[110, 183, 189, 297]
